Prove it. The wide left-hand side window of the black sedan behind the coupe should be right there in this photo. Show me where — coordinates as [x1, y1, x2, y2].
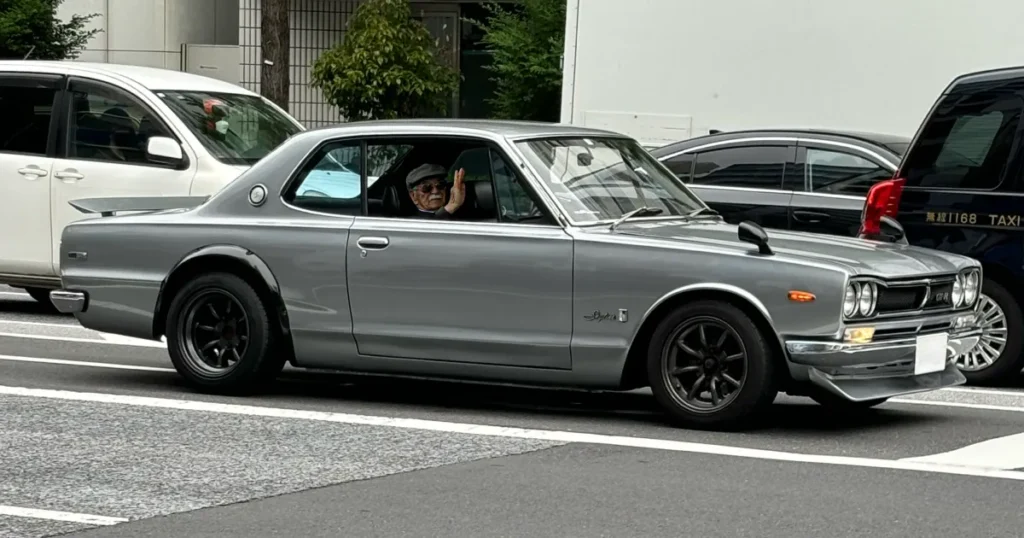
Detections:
[693, 146, 792, 189]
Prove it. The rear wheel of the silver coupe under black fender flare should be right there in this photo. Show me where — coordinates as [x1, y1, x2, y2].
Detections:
[165, 273, 286, 395]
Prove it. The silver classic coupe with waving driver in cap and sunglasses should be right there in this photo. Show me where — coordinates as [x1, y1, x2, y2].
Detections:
[50, 120, 982, 428]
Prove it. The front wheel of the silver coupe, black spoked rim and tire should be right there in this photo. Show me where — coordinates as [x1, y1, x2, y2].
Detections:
[647, 300, 778, 429]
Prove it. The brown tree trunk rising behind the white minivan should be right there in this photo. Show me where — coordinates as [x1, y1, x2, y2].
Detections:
[260, 0, 291, 111]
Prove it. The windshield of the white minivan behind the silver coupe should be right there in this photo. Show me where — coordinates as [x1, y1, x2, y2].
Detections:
[156, 91, 302, 166]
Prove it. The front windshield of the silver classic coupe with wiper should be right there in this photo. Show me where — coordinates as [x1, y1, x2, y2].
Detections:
[516, 137, 705, 222]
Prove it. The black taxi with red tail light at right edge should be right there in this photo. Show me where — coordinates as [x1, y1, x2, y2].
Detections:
[859, 67, 1024, 385]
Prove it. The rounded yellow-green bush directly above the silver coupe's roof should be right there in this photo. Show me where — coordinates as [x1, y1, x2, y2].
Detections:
[311, 0, 459, 121]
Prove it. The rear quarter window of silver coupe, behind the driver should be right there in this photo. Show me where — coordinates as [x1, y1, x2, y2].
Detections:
[285, 141, 362, 215]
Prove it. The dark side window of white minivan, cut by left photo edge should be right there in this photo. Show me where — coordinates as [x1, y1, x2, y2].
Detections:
[0, 81, 57, 156]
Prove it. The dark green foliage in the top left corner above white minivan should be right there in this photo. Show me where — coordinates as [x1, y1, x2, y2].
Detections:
[0, 0, 99, 59]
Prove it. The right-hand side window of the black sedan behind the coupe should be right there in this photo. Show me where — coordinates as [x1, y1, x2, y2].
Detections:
[804, 148, 893, 196]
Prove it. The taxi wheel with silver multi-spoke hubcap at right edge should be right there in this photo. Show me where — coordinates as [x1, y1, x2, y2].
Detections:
[956, 279, 1024, 386]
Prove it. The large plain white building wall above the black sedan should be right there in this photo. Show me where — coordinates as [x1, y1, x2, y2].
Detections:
[562, 0, 1024, 141]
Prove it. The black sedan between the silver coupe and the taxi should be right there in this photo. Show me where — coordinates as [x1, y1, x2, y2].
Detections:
[651, 129, 910, 236]
